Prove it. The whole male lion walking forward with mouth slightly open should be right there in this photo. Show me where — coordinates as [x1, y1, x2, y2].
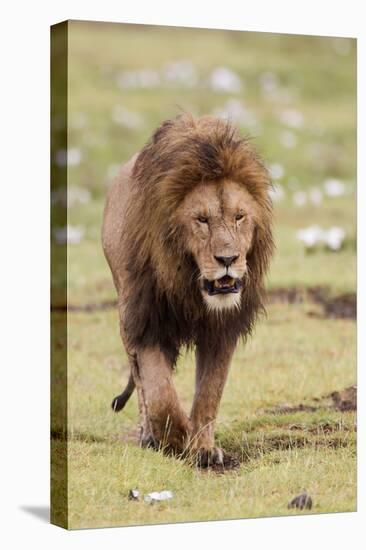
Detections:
[103, 114, 273, 466]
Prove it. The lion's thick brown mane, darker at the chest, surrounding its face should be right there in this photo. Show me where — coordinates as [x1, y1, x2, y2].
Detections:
[122, 114, 273, 362]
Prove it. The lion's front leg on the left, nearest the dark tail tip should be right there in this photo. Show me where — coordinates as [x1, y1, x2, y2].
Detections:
[133, 348, 191, 452]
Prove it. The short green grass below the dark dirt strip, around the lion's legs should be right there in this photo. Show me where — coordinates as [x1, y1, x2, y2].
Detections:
[58, 305, 356, 528]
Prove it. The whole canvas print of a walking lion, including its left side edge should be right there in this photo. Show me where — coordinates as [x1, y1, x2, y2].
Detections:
[51, 21, 357, 529]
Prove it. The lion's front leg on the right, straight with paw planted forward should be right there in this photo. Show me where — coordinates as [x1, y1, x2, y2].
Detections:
[190, 342, 235, 467]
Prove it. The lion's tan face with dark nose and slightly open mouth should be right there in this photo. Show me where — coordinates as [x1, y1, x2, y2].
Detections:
[178, 180, 256, 310]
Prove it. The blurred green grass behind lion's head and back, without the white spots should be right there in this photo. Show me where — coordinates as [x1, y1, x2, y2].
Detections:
[58, 22, 356, 304]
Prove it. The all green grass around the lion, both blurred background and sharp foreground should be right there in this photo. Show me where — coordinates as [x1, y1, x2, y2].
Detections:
[53, 22, 356, 529]
